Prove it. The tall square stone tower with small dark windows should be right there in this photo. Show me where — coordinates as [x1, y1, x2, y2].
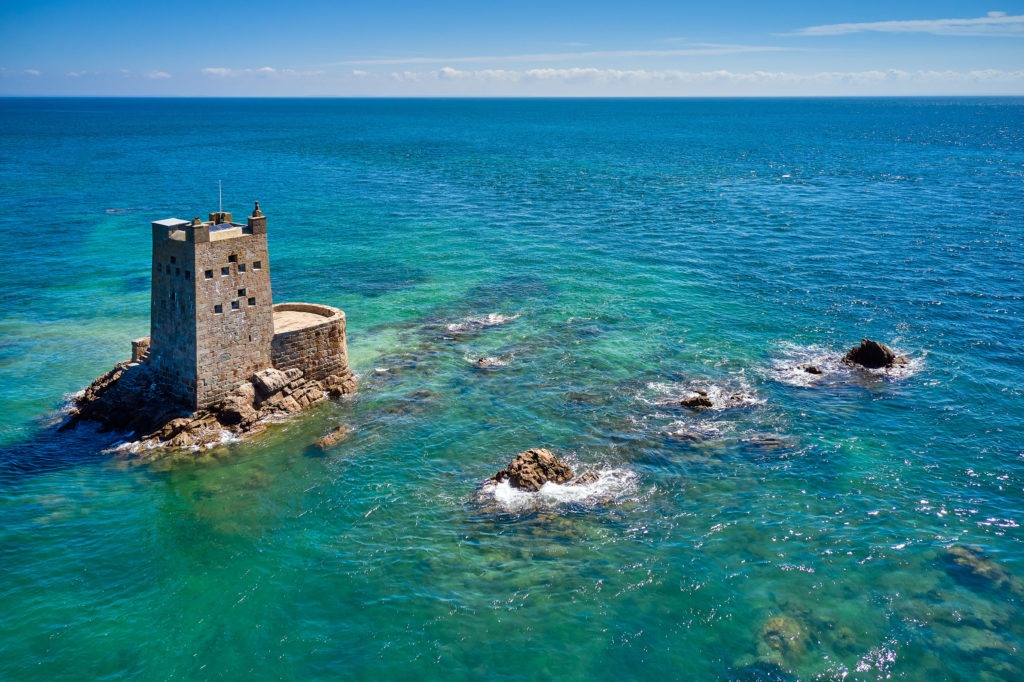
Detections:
[146, 202, 273, 410]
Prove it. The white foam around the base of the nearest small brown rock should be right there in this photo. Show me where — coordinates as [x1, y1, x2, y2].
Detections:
[477, 468, 637, 512]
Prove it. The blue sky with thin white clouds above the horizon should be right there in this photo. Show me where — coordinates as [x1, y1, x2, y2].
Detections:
[0, 0, 1024, 96]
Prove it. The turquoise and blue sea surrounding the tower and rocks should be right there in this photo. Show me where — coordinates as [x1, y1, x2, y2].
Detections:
[0, 98, 1024, 682]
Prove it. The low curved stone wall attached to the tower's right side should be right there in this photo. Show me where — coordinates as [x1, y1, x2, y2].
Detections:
[270, 303, 349, 381]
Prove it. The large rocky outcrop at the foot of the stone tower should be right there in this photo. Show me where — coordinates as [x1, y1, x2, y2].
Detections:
[61, 363, 355, 447]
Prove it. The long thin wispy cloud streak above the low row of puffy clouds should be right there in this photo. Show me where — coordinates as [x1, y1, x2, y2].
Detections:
[339, 43, 799, 67]
